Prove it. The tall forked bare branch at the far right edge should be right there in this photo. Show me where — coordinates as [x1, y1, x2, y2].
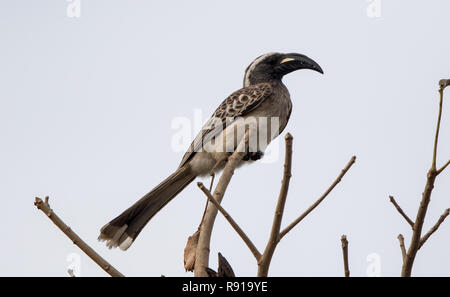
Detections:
[401, 80, 450, 277]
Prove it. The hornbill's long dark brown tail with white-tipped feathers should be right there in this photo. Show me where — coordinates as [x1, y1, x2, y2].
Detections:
[98, 166, 195, 250]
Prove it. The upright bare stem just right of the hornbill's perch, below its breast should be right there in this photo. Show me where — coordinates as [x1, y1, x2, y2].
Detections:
[258, 133, 293, 276]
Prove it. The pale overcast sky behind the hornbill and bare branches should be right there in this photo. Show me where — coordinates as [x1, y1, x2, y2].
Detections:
[0, 0, 450, 276]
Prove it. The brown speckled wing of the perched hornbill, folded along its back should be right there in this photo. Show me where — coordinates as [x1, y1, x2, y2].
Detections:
[180, 83, 273, 166]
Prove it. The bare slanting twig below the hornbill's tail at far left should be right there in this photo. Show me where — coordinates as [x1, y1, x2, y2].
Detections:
[34, 197, 124, 277]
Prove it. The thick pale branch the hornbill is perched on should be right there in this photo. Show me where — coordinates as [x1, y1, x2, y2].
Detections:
[194, 129, 249, 277]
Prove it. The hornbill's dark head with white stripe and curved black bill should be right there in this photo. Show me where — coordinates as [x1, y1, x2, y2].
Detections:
[244, 53, 323, 87]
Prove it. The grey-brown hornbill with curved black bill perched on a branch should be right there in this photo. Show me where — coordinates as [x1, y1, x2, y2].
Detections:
[98, 53, 323, 250]
